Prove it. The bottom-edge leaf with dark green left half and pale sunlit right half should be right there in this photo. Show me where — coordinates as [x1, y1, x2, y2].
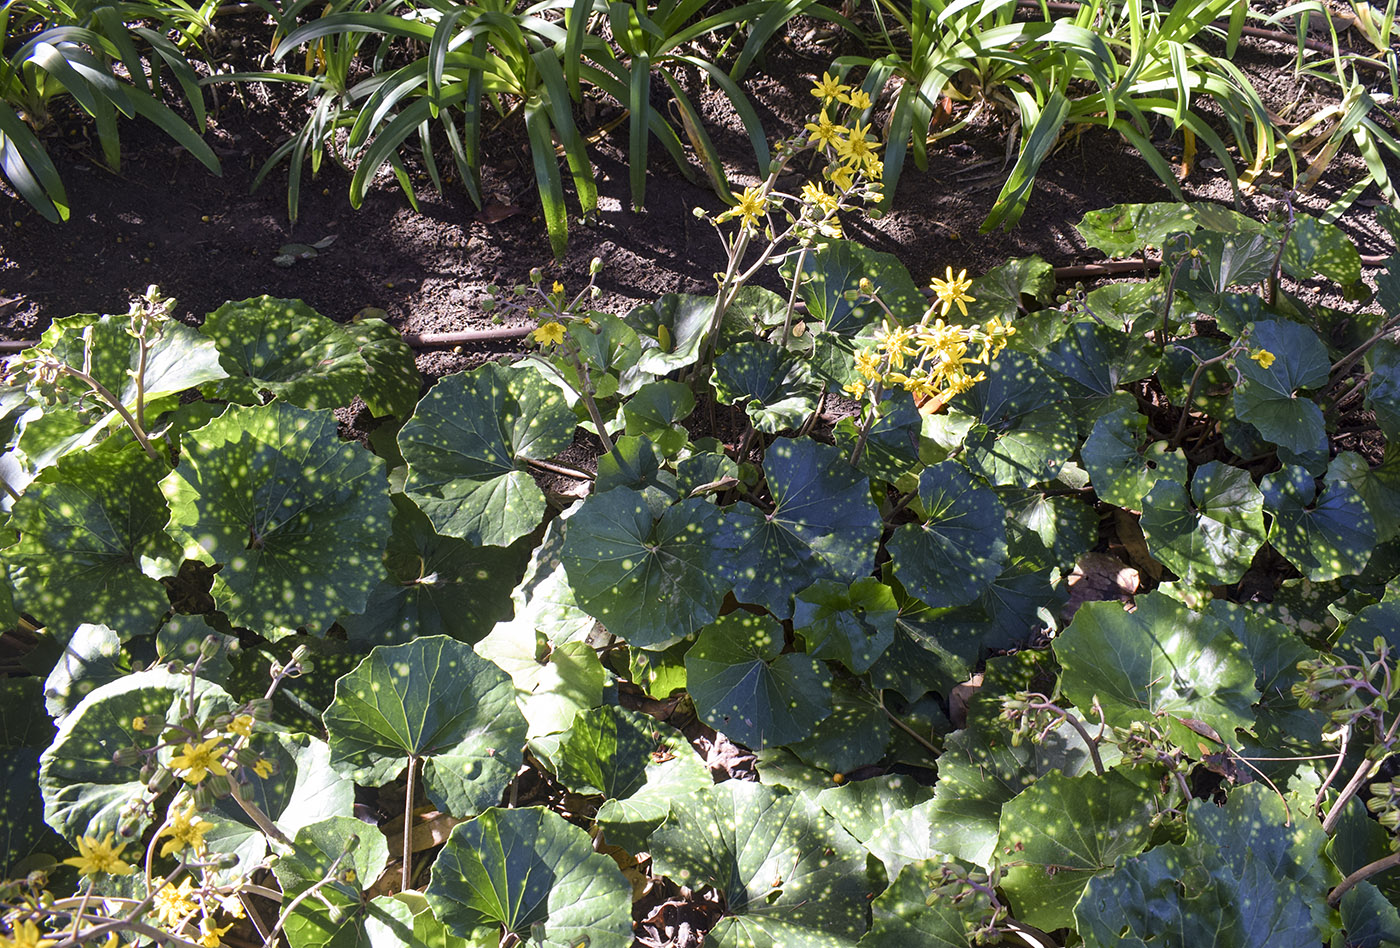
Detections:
[426, 807, 631, 948]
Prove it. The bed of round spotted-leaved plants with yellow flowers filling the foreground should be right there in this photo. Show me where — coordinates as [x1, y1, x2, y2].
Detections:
[0, 1, 1400, 948]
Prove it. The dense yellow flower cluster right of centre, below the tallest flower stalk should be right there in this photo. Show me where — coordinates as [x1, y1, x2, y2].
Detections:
[846, 267, 1015, 405]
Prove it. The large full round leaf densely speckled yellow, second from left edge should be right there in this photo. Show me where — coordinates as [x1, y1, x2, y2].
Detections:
[161, 402, 389, 632]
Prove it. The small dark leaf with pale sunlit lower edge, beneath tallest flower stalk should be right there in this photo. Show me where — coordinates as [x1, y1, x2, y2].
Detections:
[713, 342, 822, 434]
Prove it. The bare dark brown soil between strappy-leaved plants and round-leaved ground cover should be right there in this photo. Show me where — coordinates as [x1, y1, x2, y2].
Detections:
[0, 11, 1389, 378]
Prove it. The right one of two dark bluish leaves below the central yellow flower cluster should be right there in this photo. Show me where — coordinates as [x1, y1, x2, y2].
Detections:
[889, 461, 1007, 609]
